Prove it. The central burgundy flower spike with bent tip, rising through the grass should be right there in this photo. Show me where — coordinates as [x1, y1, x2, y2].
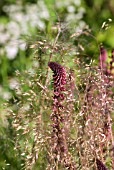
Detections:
[48, 62, 76, 170]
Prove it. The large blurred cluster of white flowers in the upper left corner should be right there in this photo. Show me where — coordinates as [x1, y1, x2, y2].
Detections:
[0, 0, 49, 60]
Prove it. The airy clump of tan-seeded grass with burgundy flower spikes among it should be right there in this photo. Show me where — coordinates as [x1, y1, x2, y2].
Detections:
[7, 25, 114, 170]
